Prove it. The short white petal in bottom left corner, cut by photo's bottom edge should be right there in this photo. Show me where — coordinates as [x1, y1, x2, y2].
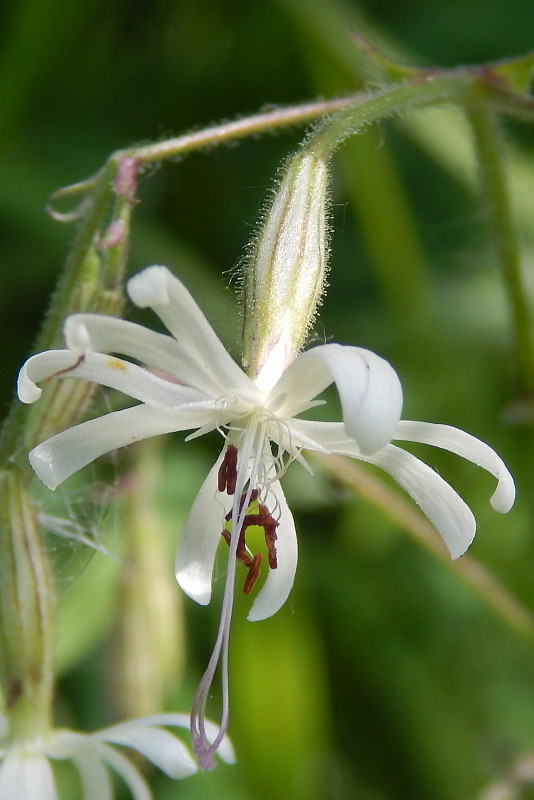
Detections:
[0, 752, 57, 800]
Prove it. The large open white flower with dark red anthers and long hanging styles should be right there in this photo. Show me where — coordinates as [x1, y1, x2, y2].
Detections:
[18, 266, 515, 767]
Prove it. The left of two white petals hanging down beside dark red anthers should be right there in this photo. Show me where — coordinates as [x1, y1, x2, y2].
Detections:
[175, 453, 225, 605]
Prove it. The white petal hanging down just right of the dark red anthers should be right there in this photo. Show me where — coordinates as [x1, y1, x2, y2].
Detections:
[247, 481, 298, 622]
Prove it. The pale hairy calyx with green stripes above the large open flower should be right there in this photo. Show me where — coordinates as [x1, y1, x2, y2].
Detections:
[243, 150, 328, 390]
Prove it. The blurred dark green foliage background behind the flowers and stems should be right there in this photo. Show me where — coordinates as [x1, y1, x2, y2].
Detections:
[0, 0, 534, 800]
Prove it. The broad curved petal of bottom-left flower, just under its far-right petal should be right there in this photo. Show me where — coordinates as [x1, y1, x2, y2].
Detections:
[92, 720, 197, 778]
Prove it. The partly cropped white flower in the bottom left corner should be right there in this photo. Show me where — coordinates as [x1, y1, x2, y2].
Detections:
[0, 714, 234, 800]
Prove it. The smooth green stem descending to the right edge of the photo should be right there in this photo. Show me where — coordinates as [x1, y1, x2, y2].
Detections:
[468, 98, 534, 394]
